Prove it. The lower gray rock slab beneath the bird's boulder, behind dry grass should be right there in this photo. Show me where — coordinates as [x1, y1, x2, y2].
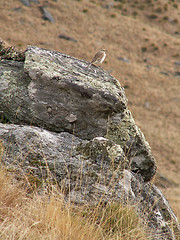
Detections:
[0, 124, 180, 239]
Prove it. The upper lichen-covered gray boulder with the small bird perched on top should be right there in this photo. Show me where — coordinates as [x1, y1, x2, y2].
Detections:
[0, 47, 156, 181]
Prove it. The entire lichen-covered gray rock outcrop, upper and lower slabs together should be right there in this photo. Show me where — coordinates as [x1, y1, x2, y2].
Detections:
[0, 47, 179, 239]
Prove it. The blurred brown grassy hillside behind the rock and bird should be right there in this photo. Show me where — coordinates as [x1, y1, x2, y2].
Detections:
[0, 0, 180, 217]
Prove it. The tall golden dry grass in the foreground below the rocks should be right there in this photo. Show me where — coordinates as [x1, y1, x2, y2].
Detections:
[0, 169, 148, 240]
